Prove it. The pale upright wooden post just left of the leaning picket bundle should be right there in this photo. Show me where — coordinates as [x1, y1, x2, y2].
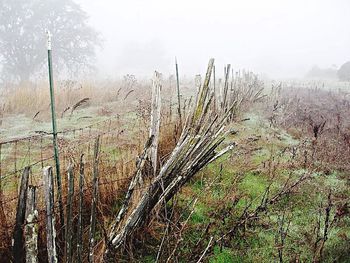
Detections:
[149, 71, 162, 175]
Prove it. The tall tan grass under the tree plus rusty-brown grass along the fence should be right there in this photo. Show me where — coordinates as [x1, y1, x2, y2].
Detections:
[0, 76, 178, 262]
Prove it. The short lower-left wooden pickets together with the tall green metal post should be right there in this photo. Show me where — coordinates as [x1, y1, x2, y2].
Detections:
[7, 31, 115, 263]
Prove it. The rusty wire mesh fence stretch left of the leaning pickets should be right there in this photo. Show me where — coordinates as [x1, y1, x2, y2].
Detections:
[0, 84, 175, 262]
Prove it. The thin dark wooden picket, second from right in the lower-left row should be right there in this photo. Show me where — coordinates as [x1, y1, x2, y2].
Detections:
[77, 154, 84, 263]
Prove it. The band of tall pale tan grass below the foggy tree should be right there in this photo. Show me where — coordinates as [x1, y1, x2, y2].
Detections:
[0, 81, 150, 120]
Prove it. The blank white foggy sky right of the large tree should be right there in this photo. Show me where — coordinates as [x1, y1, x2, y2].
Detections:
[76, 0, 350, 78]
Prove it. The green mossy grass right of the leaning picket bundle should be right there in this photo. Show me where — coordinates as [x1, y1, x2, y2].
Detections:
[168, 108, 350, 263]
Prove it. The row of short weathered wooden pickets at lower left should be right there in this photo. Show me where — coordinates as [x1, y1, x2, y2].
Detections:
[12, 136, 100, 263]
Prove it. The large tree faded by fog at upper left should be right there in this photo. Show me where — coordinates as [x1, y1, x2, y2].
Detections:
[0, 0, 101, 82]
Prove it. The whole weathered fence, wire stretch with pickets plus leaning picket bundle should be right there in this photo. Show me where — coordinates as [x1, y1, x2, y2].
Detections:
[0, 61, 262, 262]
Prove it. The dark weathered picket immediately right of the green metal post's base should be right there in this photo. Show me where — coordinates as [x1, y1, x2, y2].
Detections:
[66, 164, 74, 262]
